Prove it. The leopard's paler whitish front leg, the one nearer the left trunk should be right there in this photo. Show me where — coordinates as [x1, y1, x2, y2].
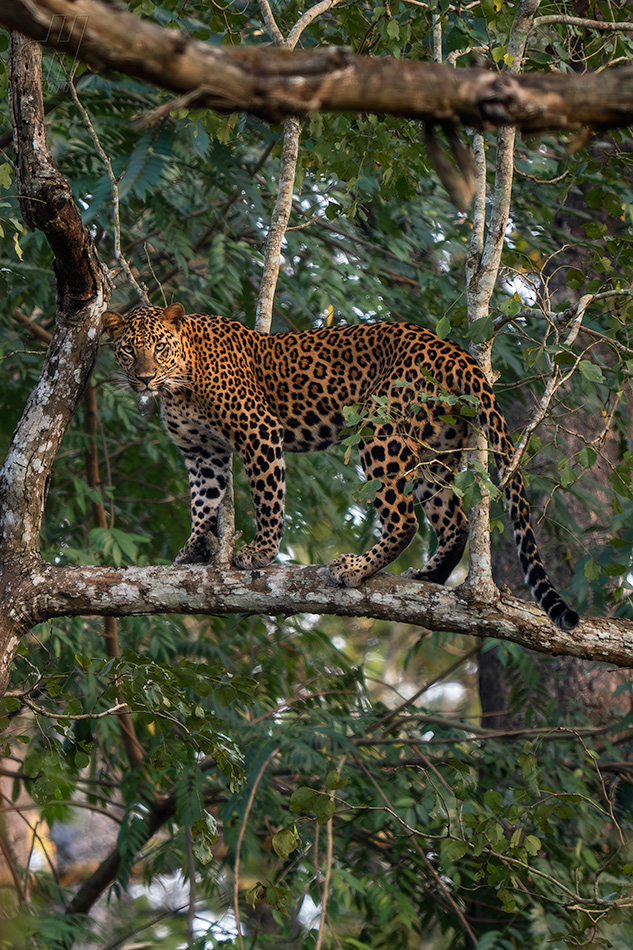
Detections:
[174, 446, 231, 564]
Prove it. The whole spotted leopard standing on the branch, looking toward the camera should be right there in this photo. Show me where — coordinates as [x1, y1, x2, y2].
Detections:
[103, 303, 579, 630]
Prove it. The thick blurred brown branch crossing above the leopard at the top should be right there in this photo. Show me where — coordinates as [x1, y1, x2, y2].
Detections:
[0, 0, 633, 132]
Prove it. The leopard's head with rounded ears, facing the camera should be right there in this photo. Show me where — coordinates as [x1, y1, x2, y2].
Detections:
[103, 303, 187, 396]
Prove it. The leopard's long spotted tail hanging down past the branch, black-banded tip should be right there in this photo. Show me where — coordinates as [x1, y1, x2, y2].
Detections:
[477, 383, 580, 630]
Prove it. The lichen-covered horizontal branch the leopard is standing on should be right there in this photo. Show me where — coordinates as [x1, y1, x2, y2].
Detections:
[6, 561, 633, 667]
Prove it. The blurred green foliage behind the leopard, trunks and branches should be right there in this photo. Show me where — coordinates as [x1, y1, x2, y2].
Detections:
[0, 0, 633, 950]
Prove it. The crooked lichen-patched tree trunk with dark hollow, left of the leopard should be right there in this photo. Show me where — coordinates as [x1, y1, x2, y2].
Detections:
[0, 34, 110, 695]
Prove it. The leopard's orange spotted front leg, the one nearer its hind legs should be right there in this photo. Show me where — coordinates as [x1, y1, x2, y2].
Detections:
[233, 415, 286, 570]
